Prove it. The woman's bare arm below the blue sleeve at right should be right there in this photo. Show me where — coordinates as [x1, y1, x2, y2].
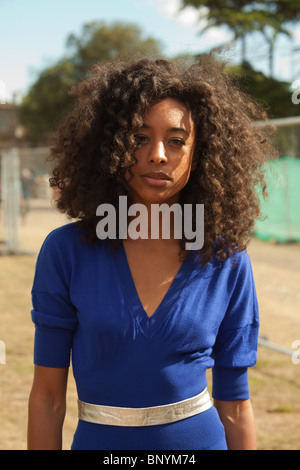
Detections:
[214, 400, 256, 450]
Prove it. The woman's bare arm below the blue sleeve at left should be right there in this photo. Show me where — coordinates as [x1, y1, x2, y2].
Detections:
[28, 366, 68, 450]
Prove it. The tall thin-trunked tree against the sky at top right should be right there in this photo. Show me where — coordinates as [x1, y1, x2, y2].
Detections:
[181, 0, 300, 76]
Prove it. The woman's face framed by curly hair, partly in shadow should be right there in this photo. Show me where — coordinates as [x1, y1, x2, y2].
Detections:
[126, 98, 195, 204]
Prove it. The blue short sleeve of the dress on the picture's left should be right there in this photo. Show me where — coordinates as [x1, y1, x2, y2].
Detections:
[31, 229, 77, 368]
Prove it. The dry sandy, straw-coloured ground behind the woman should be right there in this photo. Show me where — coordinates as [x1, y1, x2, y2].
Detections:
[0, 200, 300, 450]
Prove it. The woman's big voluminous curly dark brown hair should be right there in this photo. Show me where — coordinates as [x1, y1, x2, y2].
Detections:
[50, 57, 273, 264]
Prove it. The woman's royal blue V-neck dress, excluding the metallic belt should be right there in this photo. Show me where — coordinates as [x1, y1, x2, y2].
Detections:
[32, 223, 259, 450]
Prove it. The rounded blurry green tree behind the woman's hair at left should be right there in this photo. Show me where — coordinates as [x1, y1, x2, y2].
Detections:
[20, 22, 162, 145]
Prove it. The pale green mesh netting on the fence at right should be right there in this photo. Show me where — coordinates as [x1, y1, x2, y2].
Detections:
[254, 157, 300, 242]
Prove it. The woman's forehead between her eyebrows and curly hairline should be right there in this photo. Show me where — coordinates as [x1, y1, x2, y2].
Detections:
[144, 98, 194, 130]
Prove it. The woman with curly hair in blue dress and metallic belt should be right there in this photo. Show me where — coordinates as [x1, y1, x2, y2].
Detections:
[28, 59, 271, 450]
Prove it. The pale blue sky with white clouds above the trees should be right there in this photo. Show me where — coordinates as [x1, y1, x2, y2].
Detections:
[0, 0, 300, 102]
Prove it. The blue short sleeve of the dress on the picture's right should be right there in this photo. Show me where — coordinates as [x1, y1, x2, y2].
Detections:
[212, 252, 259, 401]
